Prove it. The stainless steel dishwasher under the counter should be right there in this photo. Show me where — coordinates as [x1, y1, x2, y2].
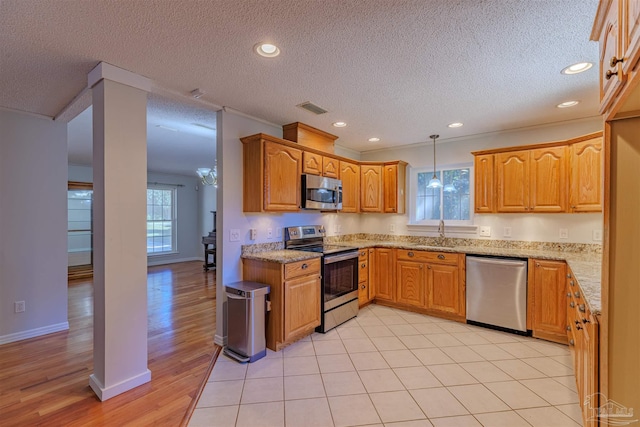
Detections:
[467, 256, 527, 334]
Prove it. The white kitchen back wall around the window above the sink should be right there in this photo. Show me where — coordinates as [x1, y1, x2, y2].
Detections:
[359, 117, 602, 243]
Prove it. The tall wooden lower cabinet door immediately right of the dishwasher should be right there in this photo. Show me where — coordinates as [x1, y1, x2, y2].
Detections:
[532, 260, 567, 343]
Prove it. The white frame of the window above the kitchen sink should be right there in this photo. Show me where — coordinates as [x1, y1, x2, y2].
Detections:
[408, 162, 475, 229]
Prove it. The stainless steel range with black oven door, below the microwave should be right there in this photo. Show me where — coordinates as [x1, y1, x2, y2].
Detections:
[284, 225, 358, 333]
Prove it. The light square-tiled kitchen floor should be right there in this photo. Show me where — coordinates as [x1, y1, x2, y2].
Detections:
[189, 305, 581, 427]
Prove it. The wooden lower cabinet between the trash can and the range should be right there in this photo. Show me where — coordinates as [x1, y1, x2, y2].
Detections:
[242, 258, 321, 351]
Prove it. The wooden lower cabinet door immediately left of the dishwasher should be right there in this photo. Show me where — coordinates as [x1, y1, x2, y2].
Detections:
[427, 264, 462, 315]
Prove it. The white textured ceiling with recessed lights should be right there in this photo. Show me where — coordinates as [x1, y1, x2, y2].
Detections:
[0, 0, 598, 172]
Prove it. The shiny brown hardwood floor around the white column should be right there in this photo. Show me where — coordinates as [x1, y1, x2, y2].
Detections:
[0, 262, 219, 427]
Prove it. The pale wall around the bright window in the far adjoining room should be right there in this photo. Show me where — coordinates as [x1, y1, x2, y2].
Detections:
[69, 165, 201, 265]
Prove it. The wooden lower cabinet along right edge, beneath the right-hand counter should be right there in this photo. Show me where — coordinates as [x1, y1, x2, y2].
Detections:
[565, 270, 603, 427]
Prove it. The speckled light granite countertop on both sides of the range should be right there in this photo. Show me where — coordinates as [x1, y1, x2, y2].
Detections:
[242, 239, 602, 315]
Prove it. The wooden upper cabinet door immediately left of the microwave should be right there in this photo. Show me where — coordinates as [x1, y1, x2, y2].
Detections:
[264, 141, 302, 211]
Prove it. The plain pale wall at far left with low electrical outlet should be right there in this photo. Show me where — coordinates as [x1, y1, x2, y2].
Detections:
[0, 110, 68, 344]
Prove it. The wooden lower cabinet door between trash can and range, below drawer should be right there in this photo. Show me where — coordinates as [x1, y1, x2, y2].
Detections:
[284, 274, 320, 342]
